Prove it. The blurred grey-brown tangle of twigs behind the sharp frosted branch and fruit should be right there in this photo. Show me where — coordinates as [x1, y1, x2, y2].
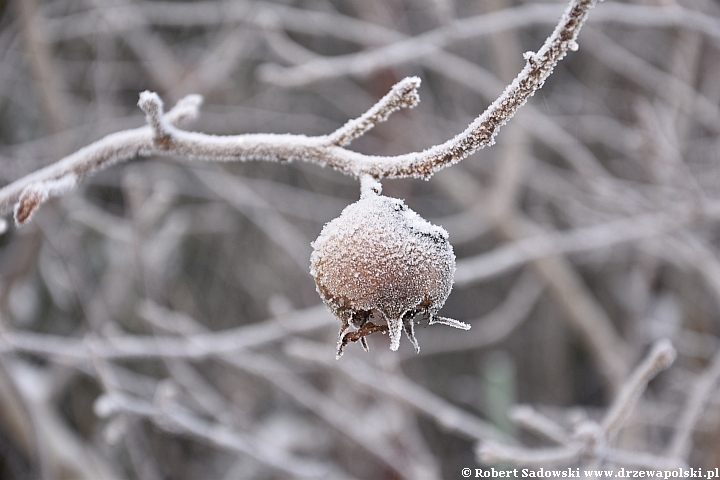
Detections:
[0, 0, 720, 479]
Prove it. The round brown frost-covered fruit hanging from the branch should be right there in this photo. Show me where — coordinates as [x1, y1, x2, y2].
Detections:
[310, 190, 470, 357]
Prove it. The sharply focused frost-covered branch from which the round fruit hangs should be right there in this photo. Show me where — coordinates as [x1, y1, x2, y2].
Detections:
[0, 0, 598, 225]
